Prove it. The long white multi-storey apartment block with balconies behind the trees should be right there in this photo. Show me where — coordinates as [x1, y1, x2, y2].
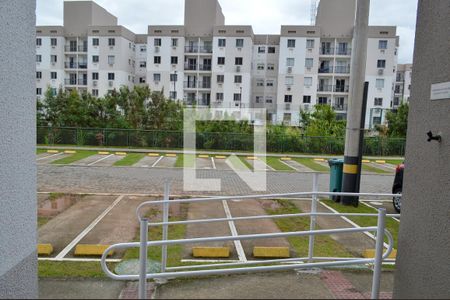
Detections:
[37, 0, 399, 128]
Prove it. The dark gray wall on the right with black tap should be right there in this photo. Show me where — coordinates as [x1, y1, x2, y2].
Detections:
[394, 0, 450, 299]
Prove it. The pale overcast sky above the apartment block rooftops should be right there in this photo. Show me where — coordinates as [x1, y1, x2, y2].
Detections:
[37, 0, 417, 63]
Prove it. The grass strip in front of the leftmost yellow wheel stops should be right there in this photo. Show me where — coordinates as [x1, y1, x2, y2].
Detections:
[38, 261, 116, 278]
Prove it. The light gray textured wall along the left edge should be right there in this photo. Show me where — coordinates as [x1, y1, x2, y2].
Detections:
[0, 0, 38, 298]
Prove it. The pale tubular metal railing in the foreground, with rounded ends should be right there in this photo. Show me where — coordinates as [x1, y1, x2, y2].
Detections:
[101, 174, 401, 299]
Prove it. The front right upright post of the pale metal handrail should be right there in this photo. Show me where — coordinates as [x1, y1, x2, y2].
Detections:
[371, 208, 386, 299]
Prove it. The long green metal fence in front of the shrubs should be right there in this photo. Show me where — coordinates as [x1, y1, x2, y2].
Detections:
[37, 127, 406, 156]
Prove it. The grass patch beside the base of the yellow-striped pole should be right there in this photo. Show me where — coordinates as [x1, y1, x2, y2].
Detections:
[322, 200, 400, 249]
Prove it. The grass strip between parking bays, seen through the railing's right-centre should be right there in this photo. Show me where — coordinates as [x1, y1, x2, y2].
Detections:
[266, 200, 352, 257]
